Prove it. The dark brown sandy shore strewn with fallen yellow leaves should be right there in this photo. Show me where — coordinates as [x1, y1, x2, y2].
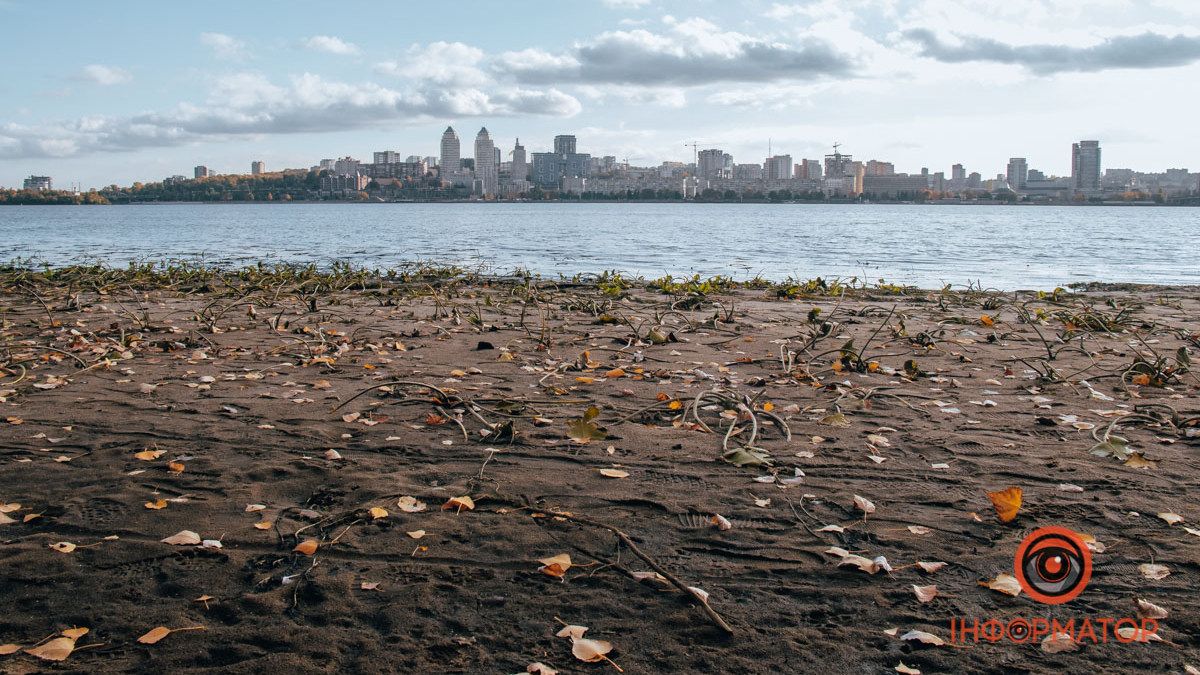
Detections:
[0, 270, 1200, 673]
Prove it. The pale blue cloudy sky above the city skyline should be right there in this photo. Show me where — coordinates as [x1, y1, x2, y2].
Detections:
[0, 0, 1200, 189]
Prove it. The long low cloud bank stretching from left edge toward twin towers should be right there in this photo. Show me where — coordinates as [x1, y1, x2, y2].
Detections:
[0, 73, 581, 159]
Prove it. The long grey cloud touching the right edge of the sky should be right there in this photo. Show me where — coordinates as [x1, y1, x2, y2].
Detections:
[901, 29, 1200, 74]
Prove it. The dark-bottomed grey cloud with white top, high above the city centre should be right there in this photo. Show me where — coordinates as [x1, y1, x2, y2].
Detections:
[494, 17, 852, 86]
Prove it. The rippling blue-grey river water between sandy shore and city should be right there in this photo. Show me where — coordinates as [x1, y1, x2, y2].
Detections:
[0, 203, 1200, 289]
